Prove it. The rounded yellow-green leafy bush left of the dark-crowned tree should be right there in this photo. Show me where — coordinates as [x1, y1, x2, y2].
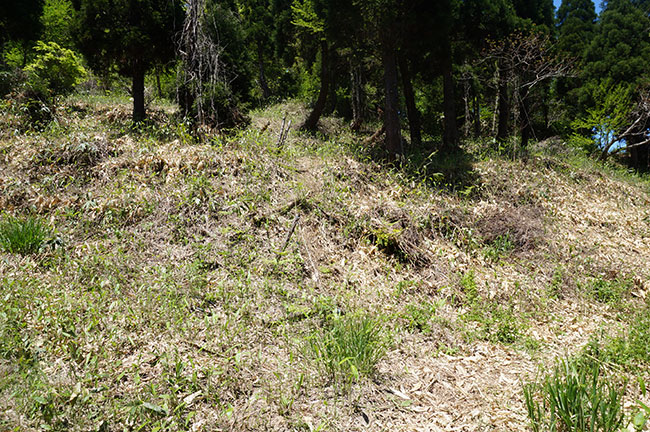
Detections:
[25, 41, 86, 96]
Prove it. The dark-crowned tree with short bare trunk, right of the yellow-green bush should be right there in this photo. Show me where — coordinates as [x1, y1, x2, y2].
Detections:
[75, 0, 183, 122]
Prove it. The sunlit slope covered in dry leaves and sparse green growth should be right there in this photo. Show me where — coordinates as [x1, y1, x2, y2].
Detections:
[0, 98, 650, 432]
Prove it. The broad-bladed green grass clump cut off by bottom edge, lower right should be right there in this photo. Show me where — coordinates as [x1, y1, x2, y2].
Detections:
[524, 359, 625, 432]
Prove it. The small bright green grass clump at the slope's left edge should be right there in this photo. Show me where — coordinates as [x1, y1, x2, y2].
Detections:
[0, 216, 50, 255]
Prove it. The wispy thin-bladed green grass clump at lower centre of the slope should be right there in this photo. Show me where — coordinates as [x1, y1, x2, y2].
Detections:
[308, 315, 387, 385]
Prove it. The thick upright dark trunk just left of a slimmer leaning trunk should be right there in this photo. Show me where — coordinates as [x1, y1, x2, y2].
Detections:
[381, 31, 403, 159]
